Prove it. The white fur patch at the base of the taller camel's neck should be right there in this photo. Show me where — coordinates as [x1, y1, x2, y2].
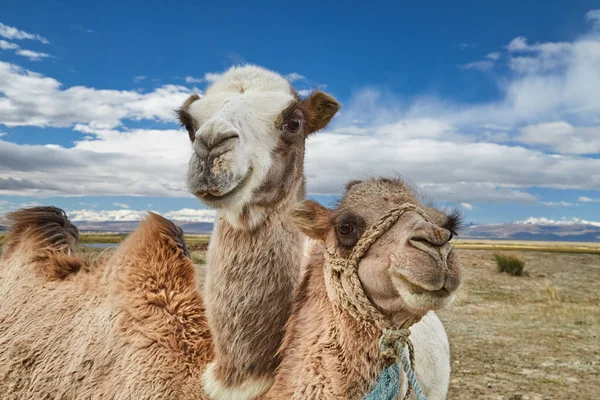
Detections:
[202, 363, 273, 400]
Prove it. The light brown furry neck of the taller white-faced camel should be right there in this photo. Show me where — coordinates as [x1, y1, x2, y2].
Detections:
[204, 193, 303, 386]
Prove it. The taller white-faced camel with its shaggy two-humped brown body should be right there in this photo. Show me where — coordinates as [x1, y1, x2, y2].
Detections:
[0, 66, 458, 399]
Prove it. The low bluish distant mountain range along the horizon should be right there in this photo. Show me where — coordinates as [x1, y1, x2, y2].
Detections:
[0, 221, 600, 242]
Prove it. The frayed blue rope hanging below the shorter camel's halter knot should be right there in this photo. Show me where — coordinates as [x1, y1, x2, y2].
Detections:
[362, 341, 427, 400]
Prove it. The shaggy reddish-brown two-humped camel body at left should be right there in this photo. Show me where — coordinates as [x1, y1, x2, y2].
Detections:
[0, 207, 212, 400]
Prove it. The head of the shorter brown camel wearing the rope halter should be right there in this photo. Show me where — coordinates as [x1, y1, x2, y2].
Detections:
[291, 179, 462, 321]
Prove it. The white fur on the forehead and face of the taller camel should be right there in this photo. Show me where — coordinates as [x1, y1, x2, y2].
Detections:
[188, 66, 294, 227]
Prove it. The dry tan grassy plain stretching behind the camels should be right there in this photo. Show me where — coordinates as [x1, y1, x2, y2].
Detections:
[2, 235, 600, 400]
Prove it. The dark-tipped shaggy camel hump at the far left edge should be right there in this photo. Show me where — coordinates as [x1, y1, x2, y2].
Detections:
[3, 206, 82, 280]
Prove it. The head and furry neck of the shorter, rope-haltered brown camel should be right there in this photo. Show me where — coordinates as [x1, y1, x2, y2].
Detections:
[265, 179, 461, 400]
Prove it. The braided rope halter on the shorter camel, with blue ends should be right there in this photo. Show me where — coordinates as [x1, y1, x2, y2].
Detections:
[325, 203, 431, 400]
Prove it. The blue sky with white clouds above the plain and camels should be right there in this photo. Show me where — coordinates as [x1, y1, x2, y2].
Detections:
[0, 0, 600, 223]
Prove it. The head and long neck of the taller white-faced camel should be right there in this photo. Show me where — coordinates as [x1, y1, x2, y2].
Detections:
[179, 66, 339, 400]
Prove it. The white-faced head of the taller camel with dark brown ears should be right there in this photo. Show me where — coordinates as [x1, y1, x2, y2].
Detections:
[178, 66, 340, 225]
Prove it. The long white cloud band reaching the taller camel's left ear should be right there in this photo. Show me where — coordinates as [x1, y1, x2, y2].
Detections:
[0, 61, 197, 128]
